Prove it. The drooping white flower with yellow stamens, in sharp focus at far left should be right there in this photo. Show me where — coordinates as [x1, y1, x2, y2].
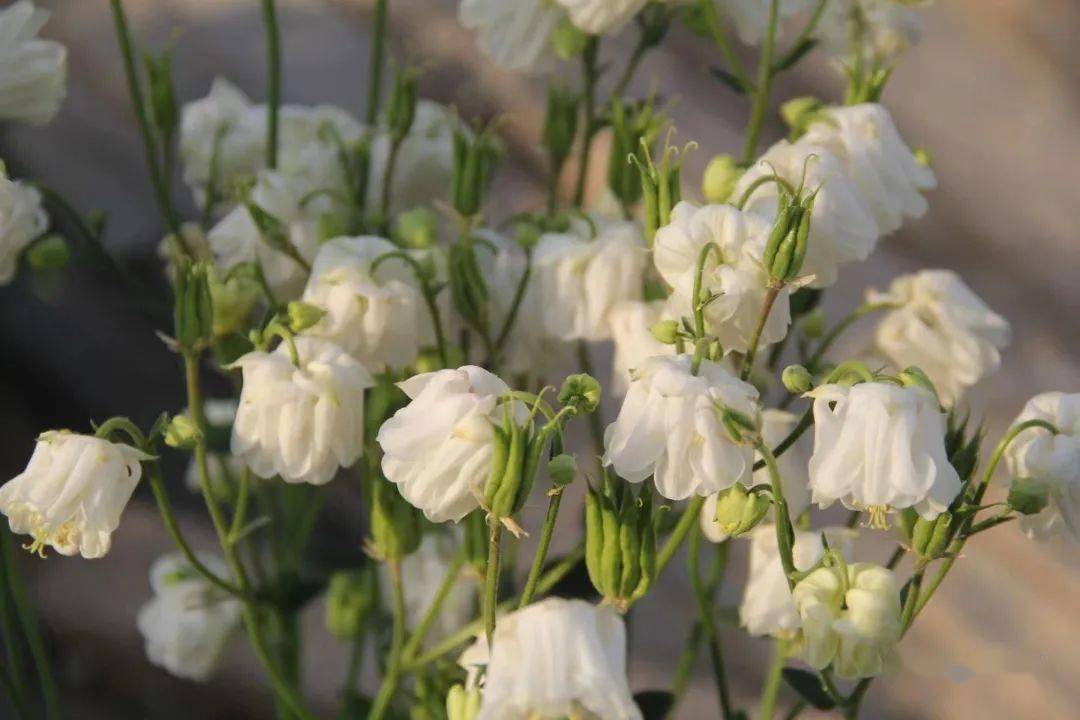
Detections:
[0, 431, 150, 559]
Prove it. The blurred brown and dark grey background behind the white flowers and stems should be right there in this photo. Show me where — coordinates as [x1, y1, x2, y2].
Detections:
[0, 0, 1080, 719]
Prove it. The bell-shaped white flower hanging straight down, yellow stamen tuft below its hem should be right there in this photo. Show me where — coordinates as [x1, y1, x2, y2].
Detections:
[809, 382, 960, 525]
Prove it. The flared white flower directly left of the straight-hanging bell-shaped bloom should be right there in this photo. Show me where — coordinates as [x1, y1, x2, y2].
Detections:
[604, 355, 757, 500]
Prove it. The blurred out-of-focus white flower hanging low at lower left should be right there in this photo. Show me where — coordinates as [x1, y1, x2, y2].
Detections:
[136, 553, 241, 681]
